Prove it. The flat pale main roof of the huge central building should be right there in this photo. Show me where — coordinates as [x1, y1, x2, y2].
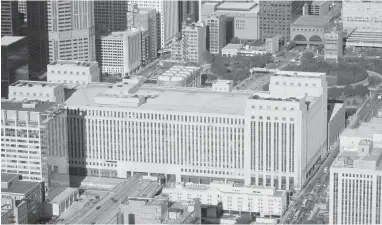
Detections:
[66, 84, 250, 115]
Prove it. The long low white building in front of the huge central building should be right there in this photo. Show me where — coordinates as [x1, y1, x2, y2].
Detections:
[162, 181, 288, 216]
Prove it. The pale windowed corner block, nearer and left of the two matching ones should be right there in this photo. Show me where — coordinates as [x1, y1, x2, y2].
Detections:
[8, 80, 65, 104]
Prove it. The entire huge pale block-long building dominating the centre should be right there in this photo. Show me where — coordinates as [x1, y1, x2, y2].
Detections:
[66, 71, 327, 189]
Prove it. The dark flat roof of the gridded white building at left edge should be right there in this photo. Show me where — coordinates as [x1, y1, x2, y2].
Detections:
[1, 100, 57, 113]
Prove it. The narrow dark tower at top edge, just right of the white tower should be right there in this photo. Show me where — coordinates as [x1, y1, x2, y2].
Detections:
[178, 0, 200, 32]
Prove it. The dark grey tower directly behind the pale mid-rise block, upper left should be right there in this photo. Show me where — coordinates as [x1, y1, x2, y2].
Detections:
[94, 0, 128, 32]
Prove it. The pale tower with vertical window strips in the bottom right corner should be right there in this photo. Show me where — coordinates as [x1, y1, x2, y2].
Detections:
[329, 141, 382, 224]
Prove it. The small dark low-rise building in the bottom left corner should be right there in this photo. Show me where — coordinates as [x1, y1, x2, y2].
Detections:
[1, 173, 44, 224]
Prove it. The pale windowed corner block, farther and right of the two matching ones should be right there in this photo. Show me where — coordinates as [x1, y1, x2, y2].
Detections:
[47, 60, 100, 84]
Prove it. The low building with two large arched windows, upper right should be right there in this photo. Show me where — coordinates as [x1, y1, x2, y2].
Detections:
[290, 15, 332, 45]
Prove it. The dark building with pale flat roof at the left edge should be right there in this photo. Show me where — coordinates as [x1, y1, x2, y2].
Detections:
[1, 36, 29, 98]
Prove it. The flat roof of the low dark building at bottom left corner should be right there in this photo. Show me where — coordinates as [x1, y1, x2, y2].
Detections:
[1, 173, 40, 194]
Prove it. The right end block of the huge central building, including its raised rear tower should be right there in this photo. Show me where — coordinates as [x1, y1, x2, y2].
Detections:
[244, 71, 327, 189]
